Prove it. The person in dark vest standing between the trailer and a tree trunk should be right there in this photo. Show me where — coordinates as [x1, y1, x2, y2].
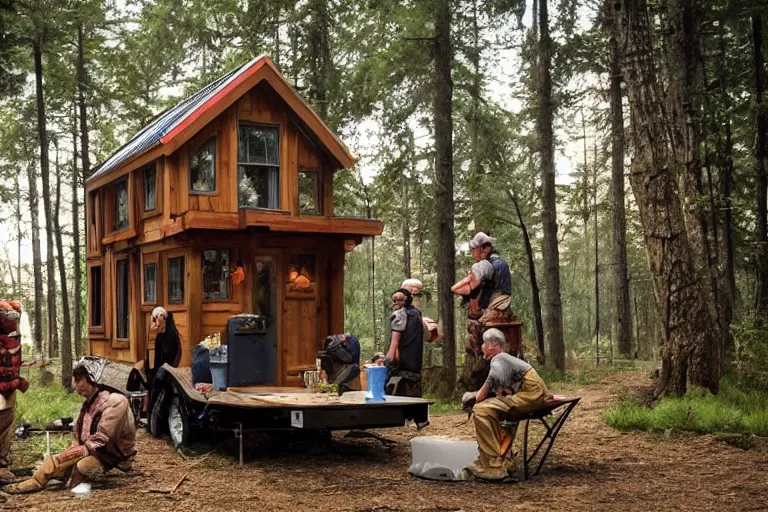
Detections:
[386, 288, 424, 398]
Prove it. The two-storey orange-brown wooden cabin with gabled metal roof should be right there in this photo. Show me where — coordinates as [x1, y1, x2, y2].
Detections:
[86, 57, 382, 386]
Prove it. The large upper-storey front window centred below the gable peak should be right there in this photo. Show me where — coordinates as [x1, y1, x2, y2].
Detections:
[237, 124, 280, 210]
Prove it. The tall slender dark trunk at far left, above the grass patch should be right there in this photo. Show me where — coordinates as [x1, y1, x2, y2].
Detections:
[33, 38, 59, 357]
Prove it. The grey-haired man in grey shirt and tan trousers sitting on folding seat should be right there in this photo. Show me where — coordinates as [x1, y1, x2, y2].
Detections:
[462, 328, 552, 480]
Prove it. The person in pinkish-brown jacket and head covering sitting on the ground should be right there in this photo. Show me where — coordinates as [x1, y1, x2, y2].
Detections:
[3, 357, 136, 494]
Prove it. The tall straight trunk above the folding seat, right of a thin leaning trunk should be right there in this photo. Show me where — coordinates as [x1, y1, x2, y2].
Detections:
[538, 0, 565, 371]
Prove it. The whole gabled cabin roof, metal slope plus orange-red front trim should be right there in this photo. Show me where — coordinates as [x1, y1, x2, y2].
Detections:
[86, 55, 357, 184]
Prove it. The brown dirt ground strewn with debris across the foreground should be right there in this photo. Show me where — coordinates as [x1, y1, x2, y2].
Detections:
[0, 372, 768, 512]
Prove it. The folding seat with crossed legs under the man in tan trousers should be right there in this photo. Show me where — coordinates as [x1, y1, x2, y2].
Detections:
[504, 396, 581, 480]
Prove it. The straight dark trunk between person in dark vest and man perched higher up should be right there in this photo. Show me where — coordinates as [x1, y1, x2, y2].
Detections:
[434, 0, 456, 394]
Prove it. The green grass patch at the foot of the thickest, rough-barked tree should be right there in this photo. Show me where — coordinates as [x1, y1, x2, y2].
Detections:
[602, 378, 768, 436]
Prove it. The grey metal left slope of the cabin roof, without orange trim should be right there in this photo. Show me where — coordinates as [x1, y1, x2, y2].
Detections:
[86, 55, 264, 183]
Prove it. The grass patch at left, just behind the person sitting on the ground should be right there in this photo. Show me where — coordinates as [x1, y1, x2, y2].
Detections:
[16, 385, 83, 428]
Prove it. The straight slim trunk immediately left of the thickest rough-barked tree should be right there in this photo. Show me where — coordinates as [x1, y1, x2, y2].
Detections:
[606, 0, 632, 357]
